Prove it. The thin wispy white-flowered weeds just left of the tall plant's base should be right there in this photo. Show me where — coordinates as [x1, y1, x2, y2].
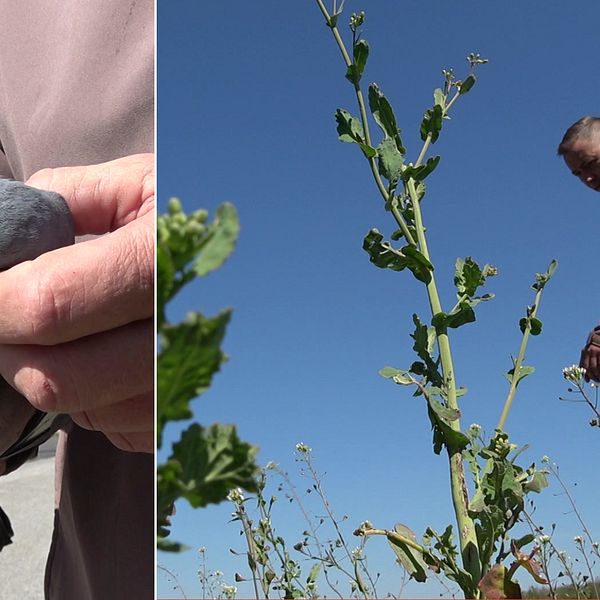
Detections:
[228, 443, 376, 599]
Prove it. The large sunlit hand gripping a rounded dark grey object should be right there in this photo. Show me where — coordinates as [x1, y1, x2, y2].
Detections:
[0, 154, 155, 452]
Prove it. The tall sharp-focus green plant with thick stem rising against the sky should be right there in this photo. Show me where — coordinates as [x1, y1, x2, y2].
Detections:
[316, 0, 556, 598]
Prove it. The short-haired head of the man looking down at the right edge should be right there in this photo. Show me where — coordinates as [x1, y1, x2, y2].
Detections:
[558, 116, 600, 192]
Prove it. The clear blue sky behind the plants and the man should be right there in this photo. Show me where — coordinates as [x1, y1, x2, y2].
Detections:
[158, 0, 600, 597]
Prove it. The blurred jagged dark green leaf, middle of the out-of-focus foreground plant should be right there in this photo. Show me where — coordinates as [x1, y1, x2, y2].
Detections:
[157, 310, 231, 447]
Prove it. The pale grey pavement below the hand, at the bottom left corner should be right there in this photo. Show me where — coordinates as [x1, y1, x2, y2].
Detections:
[0, 440, 56, 600]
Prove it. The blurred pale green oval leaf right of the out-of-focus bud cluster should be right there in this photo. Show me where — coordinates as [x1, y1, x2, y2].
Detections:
[194, 202, 240, 276]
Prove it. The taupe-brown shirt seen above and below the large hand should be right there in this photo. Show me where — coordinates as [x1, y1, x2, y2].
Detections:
[0, 0, 155, 600]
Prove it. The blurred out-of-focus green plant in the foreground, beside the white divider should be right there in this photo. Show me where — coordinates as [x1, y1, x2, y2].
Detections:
[157, 198, 259, 551]
